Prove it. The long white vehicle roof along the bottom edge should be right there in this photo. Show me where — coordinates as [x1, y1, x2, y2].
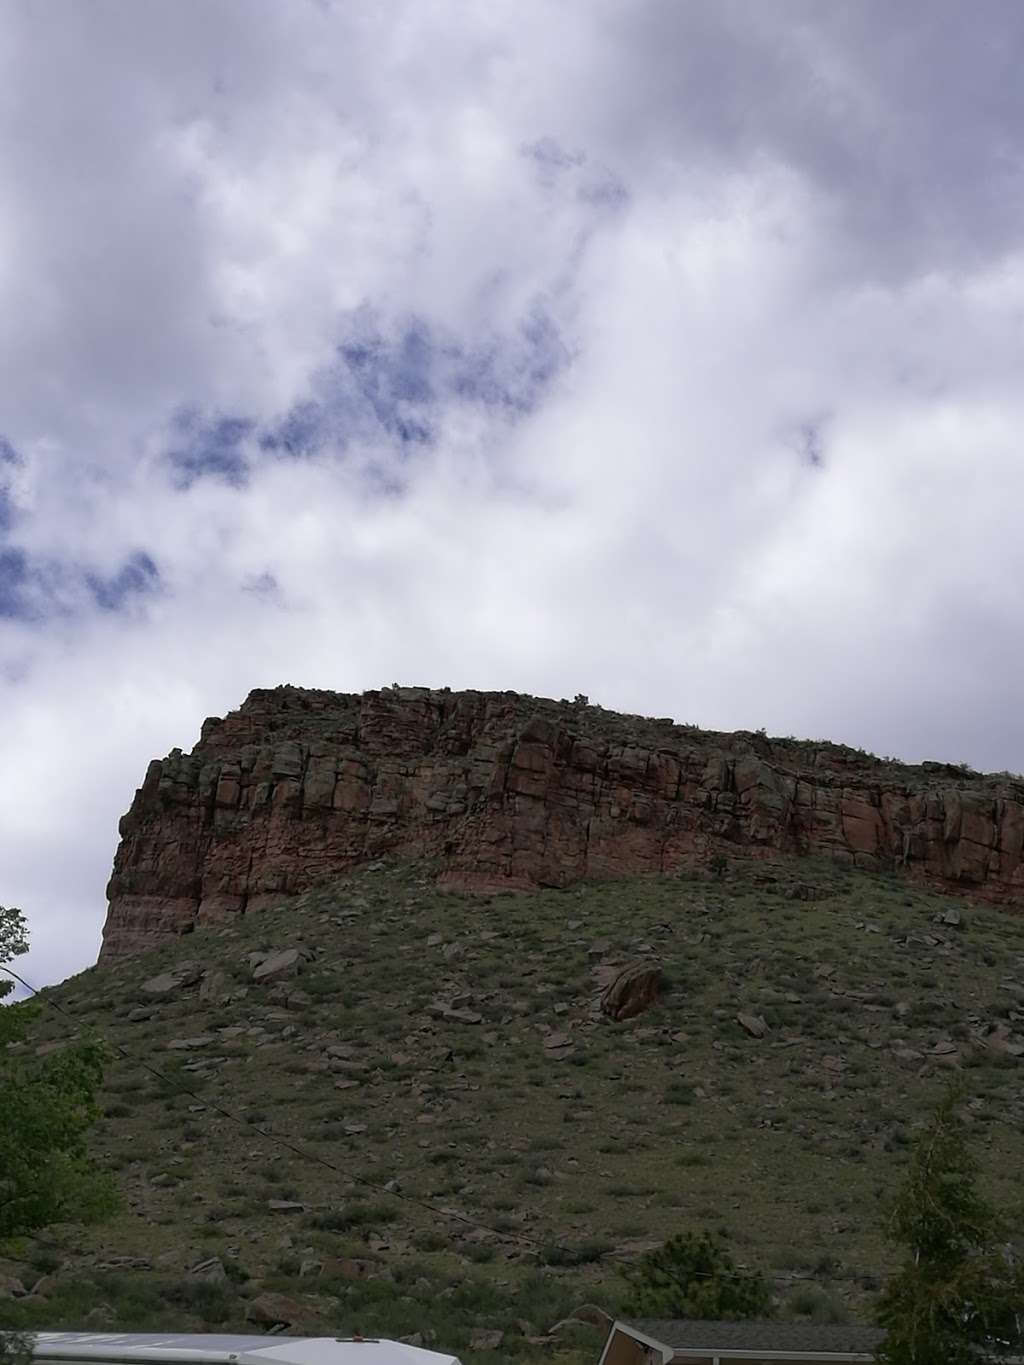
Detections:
[33, 1332, 459, 1365]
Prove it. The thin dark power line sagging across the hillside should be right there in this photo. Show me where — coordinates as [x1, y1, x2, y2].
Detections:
[0, 964, 884, 1283]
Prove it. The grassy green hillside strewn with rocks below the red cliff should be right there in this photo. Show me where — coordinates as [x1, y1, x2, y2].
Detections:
[10, 859, 1024, 1362]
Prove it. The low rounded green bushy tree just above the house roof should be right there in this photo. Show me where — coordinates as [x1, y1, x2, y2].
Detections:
[624, 1231, 773, 1319]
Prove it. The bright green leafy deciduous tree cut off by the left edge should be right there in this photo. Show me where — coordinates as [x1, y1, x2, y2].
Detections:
[0, 905, 113, 1361]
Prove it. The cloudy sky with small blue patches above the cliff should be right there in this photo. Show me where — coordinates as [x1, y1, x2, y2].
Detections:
[0, 0, 1024, 984]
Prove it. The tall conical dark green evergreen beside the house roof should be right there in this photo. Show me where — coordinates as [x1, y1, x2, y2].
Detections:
[878, 1088, 1024, 1365]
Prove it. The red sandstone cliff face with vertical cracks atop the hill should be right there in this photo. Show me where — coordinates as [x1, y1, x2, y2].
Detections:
[101, 687, 1024, 960]
